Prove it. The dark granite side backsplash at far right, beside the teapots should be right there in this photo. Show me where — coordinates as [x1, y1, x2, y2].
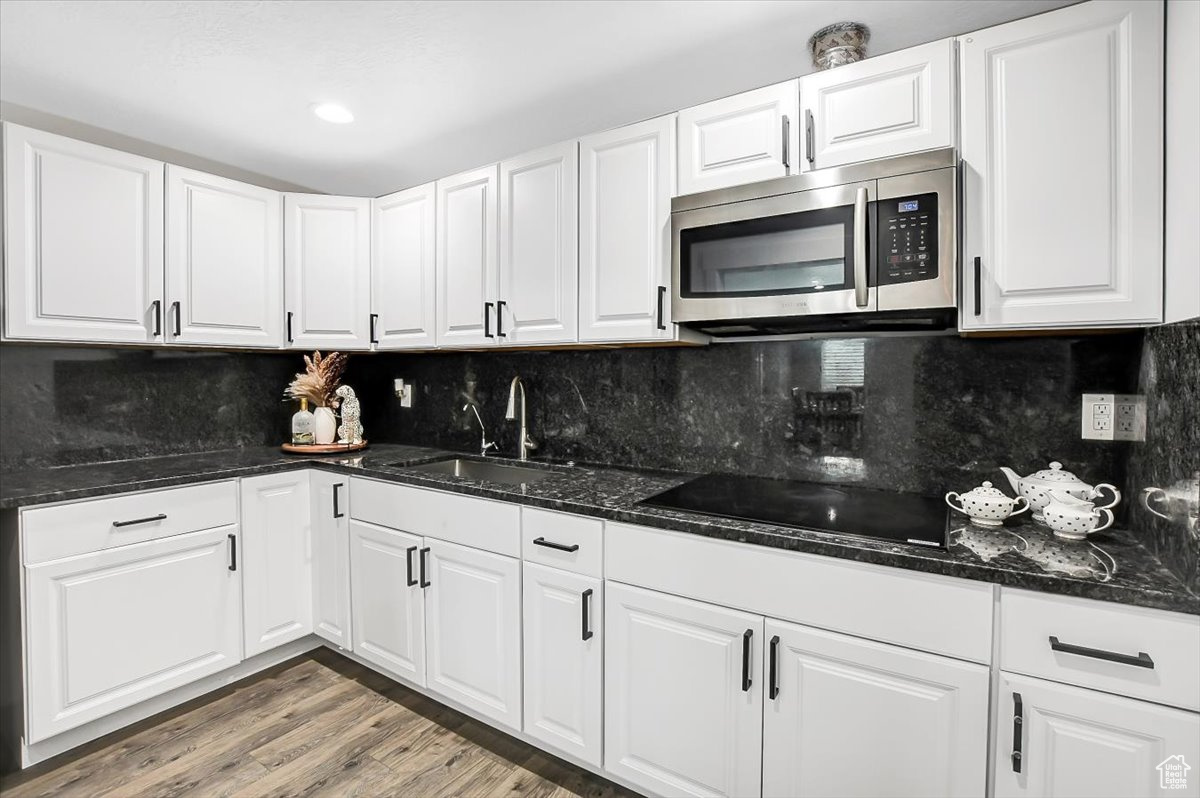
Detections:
[1126, 320, 1200, 593]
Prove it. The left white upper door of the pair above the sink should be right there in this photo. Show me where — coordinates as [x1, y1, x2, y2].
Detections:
[437, 164, 499, 347]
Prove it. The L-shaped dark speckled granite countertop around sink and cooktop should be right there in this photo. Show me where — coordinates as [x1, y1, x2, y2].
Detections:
[0, 444, 1200, 614]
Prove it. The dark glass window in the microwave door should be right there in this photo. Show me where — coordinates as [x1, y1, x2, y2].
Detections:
[682, 209, 852, 296]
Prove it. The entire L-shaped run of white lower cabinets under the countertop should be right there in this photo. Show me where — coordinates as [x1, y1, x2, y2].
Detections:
[4, 469, 1200, 798]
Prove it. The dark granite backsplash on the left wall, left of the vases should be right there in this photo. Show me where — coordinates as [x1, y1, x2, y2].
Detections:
[0, 343, 296, 470]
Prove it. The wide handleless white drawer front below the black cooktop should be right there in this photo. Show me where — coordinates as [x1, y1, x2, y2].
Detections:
[604, 522, 992, 662]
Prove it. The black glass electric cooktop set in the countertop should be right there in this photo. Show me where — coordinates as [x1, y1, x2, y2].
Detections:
[641, 474, 949, 548]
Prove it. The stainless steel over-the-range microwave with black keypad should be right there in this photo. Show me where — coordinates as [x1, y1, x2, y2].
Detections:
[671, 149, 959, 336]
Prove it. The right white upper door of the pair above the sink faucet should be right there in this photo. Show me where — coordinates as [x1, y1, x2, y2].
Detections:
[497, 142, 580, 344]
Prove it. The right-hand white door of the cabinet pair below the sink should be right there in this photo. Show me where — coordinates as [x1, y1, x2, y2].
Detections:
[425, 540, 521, 730]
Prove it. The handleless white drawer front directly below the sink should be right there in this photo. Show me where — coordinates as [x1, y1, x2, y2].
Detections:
[350, 479, 521, 557]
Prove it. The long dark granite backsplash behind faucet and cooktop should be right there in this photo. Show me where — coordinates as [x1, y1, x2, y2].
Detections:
[347, 332, 1142, 494]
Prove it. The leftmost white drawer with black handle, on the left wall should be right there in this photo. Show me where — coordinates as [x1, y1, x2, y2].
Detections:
[20, 481, 238, 565]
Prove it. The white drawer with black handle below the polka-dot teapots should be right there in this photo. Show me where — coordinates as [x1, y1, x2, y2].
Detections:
[1000, 588, 1200, 710]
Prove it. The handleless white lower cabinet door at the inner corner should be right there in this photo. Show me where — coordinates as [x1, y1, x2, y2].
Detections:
[239, 470, 312, 656]
